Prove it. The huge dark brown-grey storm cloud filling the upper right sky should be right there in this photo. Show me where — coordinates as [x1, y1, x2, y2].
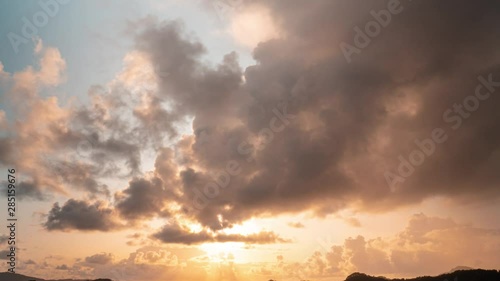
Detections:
[131, 1, 500, 231]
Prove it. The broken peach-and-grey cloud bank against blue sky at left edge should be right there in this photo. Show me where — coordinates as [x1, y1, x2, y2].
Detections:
[0, 41, 168, 200]
